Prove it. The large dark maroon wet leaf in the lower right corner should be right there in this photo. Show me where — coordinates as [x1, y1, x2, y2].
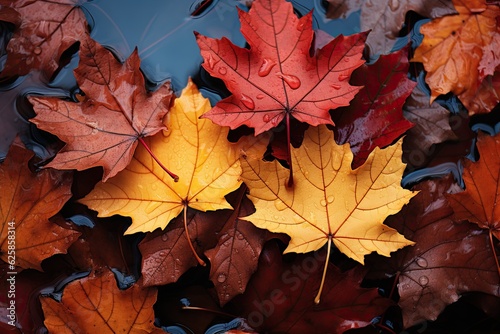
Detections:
[367, 175, 500, 327]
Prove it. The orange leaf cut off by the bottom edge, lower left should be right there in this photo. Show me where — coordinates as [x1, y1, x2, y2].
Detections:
[40, 270, 164, 333]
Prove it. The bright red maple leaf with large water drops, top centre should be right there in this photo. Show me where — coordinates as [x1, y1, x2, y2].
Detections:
[197, 0, 366, 134]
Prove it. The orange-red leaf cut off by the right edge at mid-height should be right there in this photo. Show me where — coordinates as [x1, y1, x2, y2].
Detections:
[446, 133, 500, 239]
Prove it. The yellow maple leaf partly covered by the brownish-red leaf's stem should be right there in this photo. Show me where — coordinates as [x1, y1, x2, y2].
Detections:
[81, 81, 269, 240]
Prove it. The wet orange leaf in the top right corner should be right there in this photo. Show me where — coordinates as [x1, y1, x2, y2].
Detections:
[412, 0, 500, 108]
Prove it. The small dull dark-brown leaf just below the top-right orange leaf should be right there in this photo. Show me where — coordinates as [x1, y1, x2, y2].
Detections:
[404, 83, 459, 156]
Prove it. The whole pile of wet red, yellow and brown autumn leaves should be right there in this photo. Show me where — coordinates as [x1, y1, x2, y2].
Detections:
[0, 0, 500, 333]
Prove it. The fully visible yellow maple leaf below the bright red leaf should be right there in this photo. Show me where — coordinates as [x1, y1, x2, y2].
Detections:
[238, 125, 415, 263]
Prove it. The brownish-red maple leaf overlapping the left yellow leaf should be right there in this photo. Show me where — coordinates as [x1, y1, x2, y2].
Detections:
[29, 36, 172, 181]
